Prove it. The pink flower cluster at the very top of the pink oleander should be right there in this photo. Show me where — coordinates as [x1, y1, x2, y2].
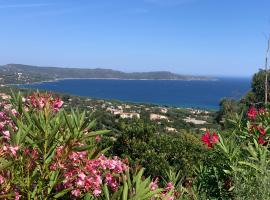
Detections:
[28, 93, 63, 112]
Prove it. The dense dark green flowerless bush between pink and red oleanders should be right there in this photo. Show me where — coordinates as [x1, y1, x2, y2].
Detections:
[103, 120, 206, 177]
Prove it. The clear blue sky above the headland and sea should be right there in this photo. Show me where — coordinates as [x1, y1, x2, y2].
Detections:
[0, 0, 270, 76]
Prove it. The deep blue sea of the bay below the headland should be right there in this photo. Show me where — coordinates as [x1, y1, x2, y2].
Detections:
[20, 78, 251, 109]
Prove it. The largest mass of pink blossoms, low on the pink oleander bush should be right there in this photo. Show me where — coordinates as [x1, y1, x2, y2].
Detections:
[50, 146, 128, 197]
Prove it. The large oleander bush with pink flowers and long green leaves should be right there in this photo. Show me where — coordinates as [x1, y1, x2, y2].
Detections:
[0, 93, 184, 200]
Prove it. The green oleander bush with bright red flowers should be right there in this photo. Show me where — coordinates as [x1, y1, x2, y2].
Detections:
[195, 106, 270, 199]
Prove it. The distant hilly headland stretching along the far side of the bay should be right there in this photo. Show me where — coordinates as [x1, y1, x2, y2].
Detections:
[0, 64, 215, 84]
